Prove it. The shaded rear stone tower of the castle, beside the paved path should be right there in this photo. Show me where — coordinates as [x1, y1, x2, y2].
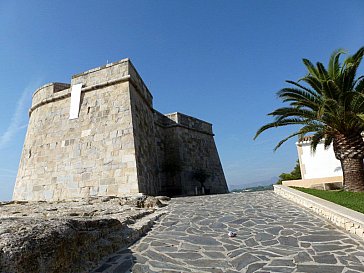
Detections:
[156, 113, 228, 195]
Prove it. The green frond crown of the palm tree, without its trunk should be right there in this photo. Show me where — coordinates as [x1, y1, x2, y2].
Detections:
[254, 47, 364, 151]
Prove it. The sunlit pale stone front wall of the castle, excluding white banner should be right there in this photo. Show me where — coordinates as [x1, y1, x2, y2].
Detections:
[13, 61, 139, 200]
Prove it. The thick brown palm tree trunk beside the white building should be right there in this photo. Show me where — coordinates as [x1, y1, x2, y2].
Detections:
[340, 157, 364, 192]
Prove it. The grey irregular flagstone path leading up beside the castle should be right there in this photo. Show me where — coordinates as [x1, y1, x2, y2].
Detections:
[93, 191, 364, 273]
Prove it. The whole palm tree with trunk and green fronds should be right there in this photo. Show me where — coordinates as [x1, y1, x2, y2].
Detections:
[254, 47, 364, 191]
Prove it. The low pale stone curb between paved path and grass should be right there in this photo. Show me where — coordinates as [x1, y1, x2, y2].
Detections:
[273, 185, 364, 239]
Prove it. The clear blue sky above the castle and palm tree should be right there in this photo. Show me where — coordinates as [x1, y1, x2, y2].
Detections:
[0, 0, 364, 200]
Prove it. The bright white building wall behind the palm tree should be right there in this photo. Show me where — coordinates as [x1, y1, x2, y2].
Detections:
[296, 141, 342, 179]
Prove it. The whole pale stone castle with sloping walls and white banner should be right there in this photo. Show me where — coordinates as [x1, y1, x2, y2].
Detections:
[13, 59, 228, 201]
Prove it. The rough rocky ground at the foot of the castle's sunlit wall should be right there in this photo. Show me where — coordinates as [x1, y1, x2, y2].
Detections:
[0, 196, 168, 273]
